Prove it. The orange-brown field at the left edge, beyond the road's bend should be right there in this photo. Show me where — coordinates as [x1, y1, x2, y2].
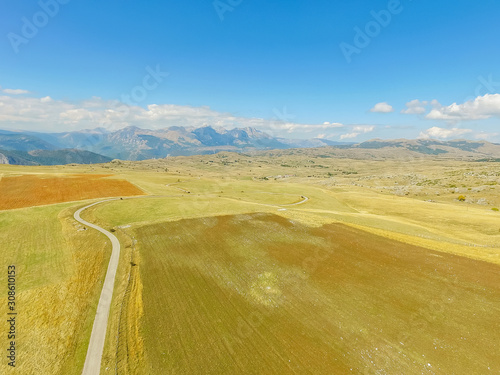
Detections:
[0, 174, 144, 210]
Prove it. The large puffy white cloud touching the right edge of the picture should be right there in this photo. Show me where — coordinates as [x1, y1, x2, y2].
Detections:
[426, 94, 500, 121]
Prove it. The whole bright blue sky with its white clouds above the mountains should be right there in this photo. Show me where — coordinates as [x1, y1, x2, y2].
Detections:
[0, 0, 500, 142]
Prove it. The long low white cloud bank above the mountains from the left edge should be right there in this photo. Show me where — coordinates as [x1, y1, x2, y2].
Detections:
[0, 95, 344, 136]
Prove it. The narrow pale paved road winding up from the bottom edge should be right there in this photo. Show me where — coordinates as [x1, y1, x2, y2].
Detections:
[74, 198, 120, 375]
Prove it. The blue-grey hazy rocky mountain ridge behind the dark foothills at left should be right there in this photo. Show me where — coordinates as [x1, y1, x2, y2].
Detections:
[0, 126, 348, 160]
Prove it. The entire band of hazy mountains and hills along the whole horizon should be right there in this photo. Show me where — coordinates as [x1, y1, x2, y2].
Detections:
[0, 126, 500, 165]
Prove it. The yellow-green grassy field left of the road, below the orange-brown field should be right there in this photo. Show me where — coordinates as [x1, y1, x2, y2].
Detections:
[0, 203, 111, 375]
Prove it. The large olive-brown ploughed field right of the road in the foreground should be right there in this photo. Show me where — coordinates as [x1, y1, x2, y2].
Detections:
[136, 213, 500, 374]
